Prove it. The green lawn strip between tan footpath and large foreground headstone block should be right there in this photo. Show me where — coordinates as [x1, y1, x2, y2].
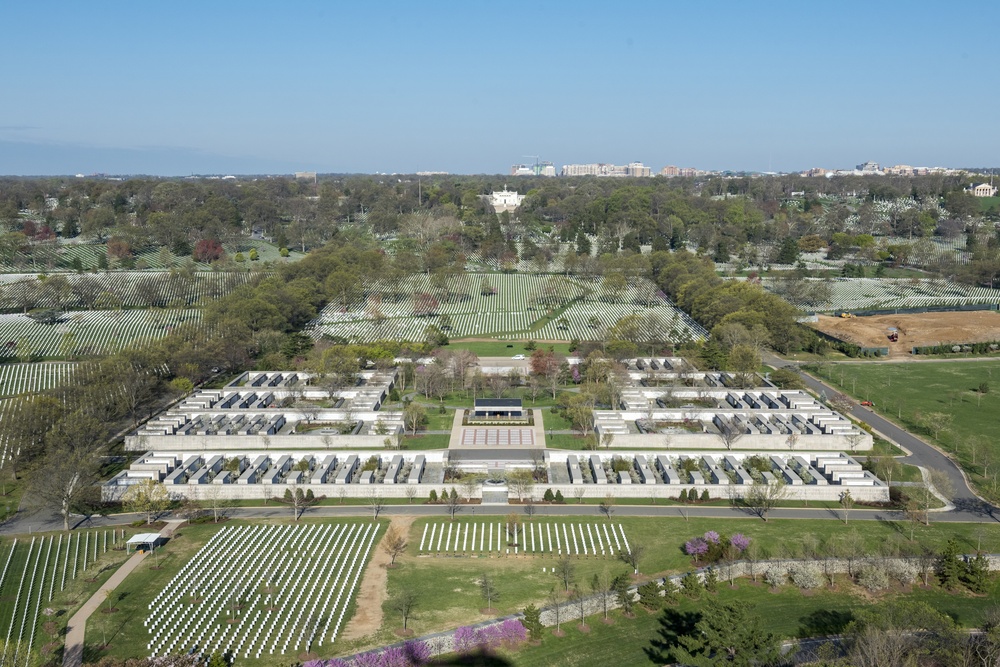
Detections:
[85, 518, 388, 667]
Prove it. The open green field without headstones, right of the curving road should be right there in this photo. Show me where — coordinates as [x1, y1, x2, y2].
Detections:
[809, 359, 1000, 501]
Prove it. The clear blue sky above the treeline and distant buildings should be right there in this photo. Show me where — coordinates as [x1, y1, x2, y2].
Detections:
[0, 0, 1000, 175]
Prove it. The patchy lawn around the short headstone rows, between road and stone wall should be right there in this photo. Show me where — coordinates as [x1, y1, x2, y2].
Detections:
[376, 509, 1000, 644]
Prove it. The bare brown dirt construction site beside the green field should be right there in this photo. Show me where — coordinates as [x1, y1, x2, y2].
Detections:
[810, 310, 1000, 357]
